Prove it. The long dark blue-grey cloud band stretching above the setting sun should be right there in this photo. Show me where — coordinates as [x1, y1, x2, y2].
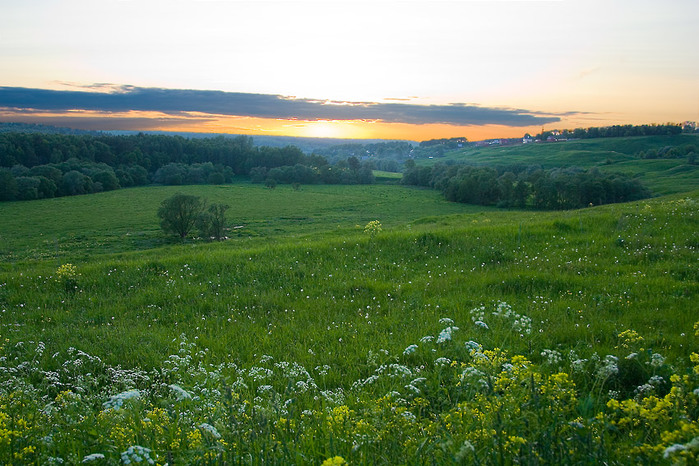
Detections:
[0, 83, 576, 127]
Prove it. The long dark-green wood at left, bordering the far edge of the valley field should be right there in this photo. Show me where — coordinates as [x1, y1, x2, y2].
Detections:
[0, 132, 373, 200]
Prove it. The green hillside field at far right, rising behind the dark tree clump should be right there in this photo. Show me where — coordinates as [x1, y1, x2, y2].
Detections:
[420, 134, 699, 195]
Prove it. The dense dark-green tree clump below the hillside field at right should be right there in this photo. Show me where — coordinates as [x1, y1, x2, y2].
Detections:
[402, 163, 650, 210]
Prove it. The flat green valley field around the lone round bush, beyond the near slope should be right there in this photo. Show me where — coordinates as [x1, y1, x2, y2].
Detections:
[0, 183, 489, 263]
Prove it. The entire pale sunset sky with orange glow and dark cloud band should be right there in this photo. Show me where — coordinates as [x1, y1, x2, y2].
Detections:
[0, 0, 699, 141]
